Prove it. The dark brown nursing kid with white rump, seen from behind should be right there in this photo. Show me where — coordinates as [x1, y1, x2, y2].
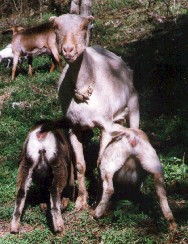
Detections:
[10, 121, 74, 233]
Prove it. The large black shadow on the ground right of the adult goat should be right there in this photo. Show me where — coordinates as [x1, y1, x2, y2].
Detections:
[111, 14, 188, 157]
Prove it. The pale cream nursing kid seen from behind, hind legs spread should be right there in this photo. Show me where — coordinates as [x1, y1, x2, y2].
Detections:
[94, 128, 176, 230]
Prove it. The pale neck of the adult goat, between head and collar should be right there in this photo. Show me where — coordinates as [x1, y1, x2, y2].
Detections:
[70, 51, 94, 92]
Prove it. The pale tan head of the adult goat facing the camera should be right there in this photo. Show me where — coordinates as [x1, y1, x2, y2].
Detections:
[50, 14, 93, 63]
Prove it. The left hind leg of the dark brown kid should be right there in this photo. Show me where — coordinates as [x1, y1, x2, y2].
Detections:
[10, 160, 33, 233]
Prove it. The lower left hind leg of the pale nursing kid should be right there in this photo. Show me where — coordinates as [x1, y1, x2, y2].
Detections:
[94, 172, 114, 218]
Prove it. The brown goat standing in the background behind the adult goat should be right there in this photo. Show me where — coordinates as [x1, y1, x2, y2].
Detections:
[11, 22, 62, 80]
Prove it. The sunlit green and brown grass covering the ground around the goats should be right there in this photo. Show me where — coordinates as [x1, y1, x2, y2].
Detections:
[0, 0, 188, 244]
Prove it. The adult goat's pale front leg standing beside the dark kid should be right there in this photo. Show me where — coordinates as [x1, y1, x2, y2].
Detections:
[70, 130, 88, 210]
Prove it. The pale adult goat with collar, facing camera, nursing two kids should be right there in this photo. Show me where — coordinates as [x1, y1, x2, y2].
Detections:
[50, 14, 139, 209]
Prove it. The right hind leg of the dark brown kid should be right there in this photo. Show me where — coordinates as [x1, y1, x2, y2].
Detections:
[50, 161, 68, 233]
